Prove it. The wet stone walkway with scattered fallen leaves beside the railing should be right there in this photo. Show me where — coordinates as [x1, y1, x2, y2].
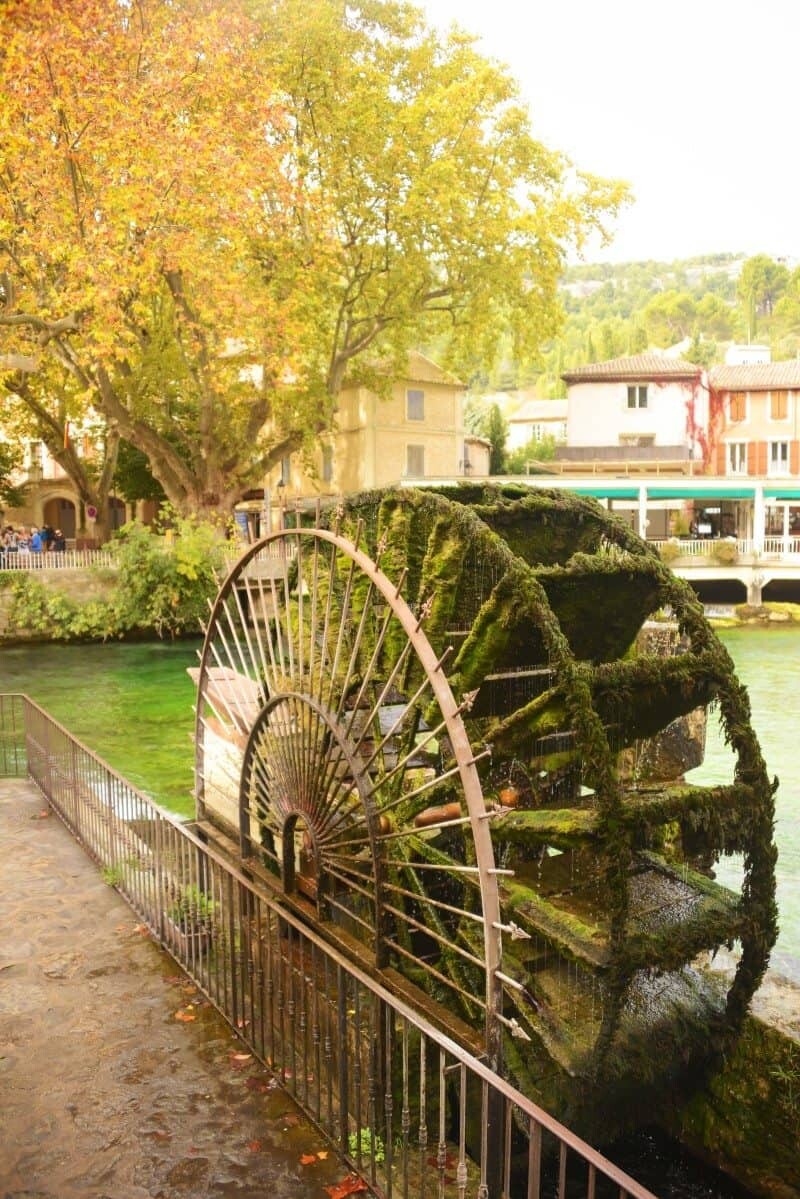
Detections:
[0, 779, 347, 1199]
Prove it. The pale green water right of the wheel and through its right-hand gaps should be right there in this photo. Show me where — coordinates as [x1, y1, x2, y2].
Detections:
[688, 628, 800, 980]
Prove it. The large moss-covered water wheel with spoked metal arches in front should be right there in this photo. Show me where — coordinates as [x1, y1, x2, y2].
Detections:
[191, 486, 776, 1132]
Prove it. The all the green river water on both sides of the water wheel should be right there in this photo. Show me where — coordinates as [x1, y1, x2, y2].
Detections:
[0, 628, 800, 977]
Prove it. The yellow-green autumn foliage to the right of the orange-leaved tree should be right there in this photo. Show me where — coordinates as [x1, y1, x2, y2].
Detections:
[252, 0, 625, 396]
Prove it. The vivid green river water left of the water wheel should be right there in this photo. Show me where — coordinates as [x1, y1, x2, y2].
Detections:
[0, 641, 199, 815]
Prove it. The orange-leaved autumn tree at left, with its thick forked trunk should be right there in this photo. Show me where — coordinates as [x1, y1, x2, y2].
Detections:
[0, 0, 327, 534]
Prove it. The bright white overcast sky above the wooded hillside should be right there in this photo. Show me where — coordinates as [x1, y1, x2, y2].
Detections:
[417, 0, 800, 260]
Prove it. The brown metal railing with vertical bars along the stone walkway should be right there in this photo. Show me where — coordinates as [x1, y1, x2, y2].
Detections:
[0, 695, 654, 1199]
